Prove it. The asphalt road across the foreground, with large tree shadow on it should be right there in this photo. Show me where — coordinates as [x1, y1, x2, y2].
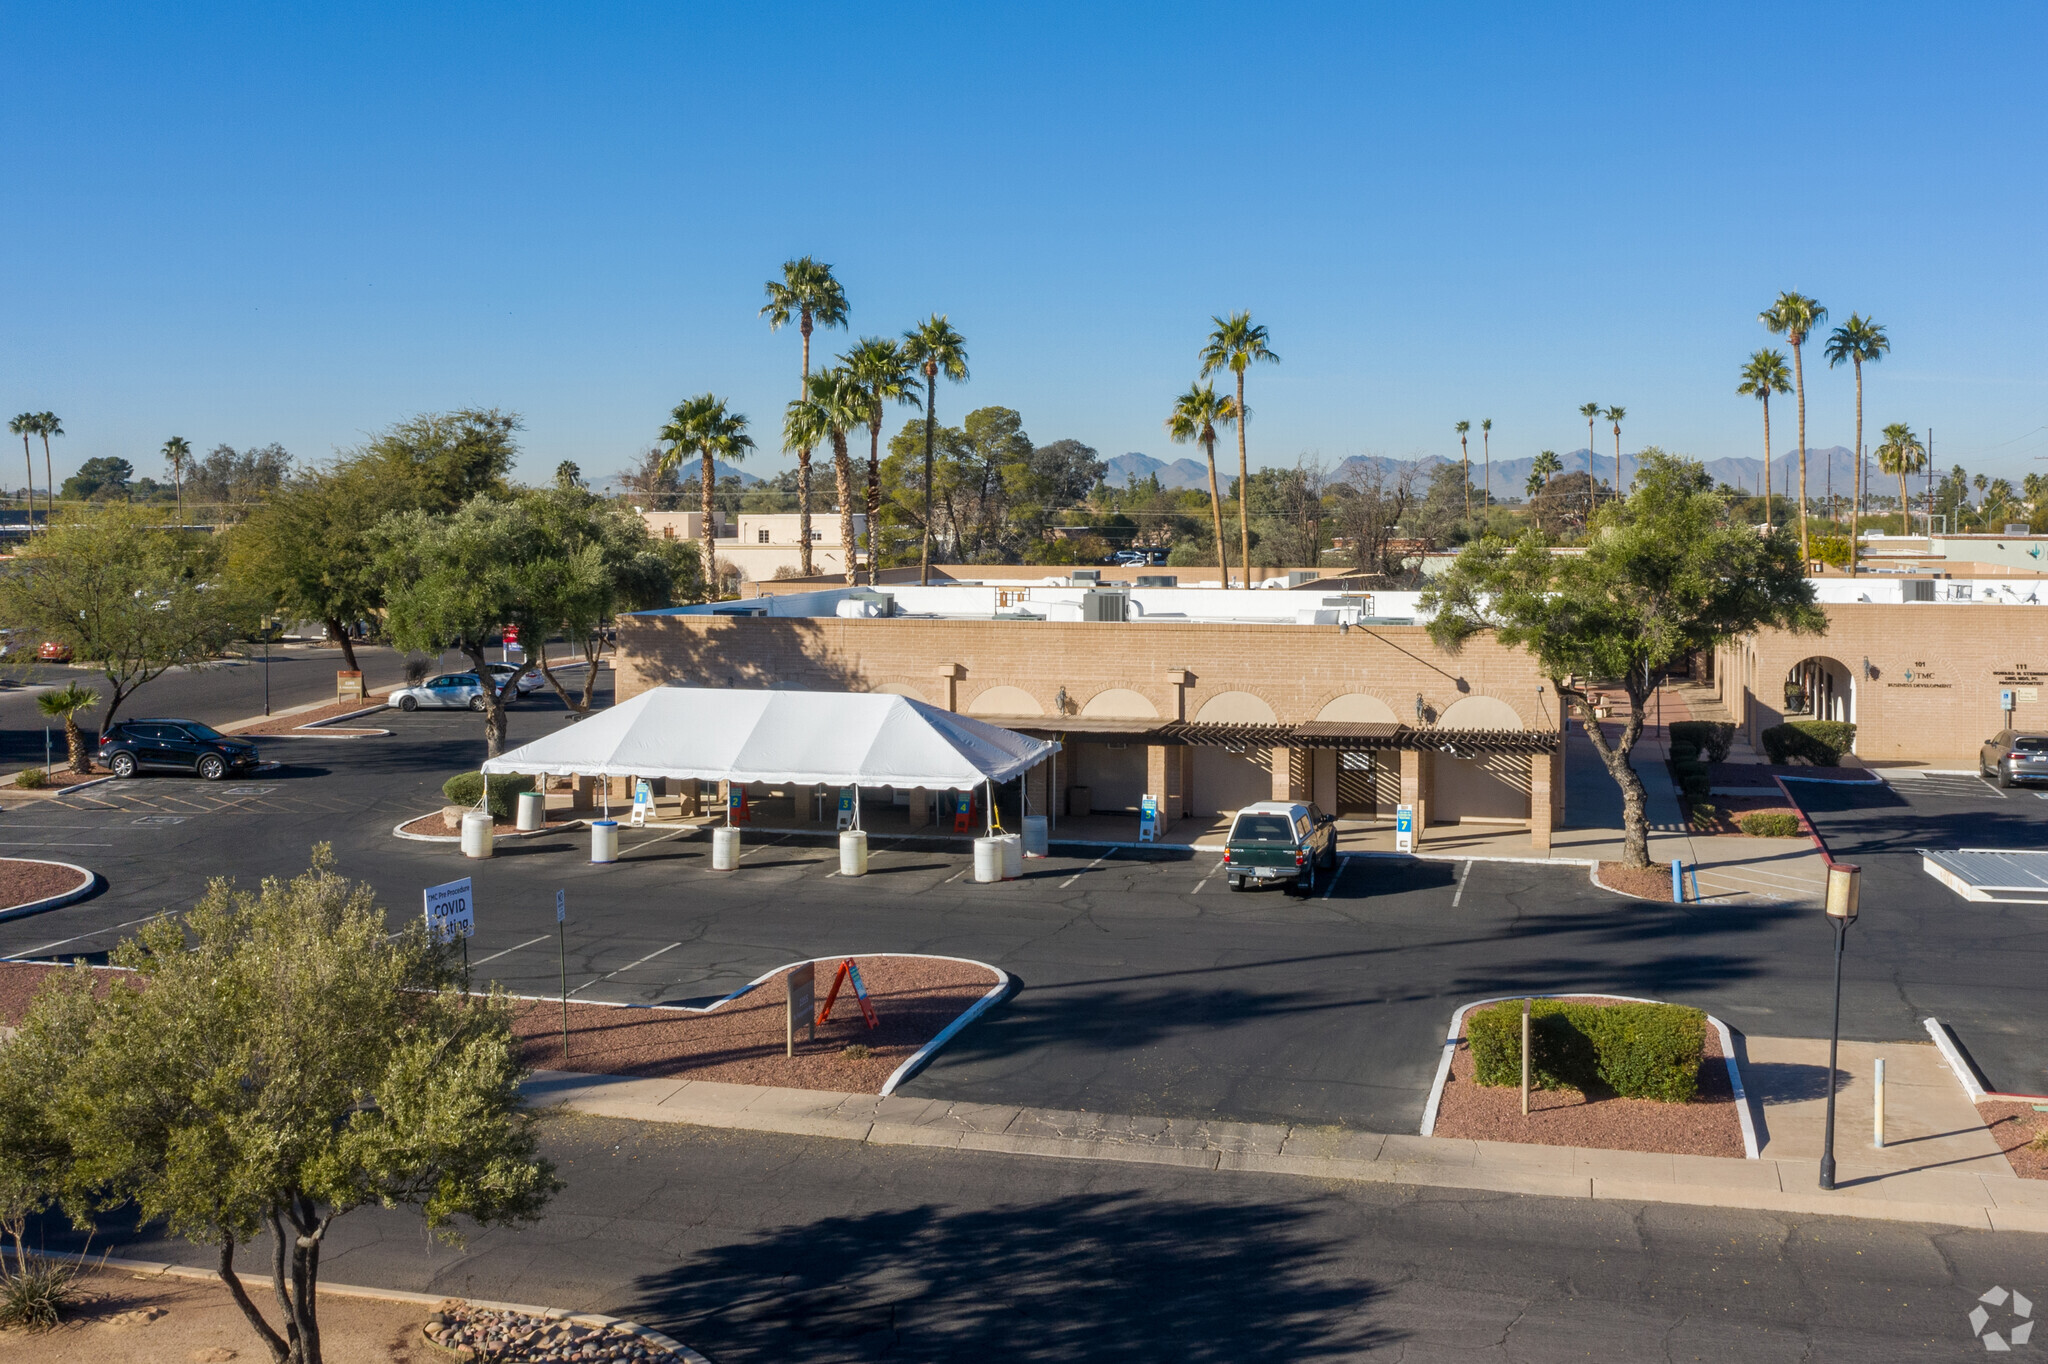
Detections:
[51, 1116, 2048, 1364]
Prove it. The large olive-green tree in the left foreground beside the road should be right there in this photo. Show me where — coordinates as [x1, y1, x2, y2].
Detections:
[19, 846, 561, 1364]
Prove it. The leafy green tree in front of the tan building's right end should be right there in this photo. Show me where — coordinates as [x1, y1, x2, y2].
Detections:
[1421, 449, 1827, 866]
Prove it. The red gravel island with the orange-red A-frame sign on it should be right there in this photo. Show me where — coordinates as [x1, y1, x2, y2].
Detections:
[514, 956, 997, 1094]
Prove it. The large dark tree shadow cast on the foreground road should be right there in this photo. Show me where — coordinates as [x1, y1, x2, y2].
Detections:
[621, 1192, 1399, 1364]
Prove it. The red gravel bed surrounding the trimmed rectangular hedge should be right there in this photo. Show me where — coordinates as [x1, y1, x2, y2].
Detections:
[1434, 999, 1743, 1159]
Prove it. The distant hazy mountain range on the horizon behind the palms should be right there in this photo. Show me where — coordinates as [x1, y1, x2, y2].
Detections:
[1102, 444, 1896, 498]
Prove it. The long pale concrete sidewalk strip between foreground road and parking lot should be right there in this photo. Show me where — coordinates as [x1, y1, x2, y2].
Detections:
[524, 1064, 2048, 1233]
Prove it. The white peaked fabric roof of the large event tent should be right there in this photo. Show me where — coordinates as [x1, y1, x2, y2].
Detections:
[483, 686, 1059, 791]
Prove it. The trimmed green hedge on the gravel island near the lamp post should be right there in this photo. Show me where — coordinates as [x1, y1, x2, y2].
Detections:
[1464, 999, 1706, 1104]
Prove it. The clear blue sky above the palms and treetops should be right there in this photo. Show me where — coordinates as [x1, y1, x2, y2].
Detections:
[0, 0, 2048, 489]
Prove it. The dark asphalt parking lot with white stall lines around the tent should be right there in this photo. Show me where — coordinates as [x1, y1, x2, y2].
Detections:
[0, 700, 2048, 1131]
